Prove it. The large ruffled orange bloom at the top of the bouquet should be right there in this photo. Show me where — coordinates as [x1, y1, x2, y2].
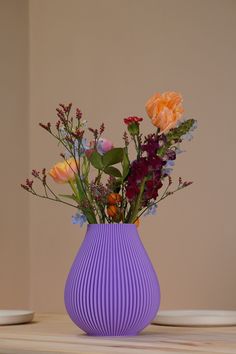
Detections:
[145, 91, 184, 133]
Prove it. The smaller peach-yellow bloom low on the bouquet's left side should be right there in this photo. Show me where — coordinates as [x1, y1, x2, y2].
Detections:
[49, 157, 77, 183]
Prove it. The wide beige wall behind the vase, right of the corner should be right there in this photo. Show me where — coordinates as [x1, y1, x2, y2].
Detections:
[0, 0, 236, 312]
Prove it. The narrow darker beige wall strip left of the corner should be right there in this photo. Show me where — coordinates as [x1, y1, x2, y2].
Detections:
[0, 0, 29, 308]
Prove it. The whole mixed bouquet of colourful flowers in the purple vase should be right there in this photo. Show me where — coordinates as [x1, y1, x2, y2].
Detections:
[21, 92, 197, 226]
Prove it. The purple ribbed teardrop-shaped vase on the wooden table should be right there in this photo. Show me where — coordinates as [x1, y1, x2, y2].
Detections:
[65, 224, 160, 336]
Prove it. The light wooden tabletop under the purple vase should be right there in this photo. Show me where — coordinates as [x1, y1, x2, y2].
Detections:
[0, 314, 236, 354]
